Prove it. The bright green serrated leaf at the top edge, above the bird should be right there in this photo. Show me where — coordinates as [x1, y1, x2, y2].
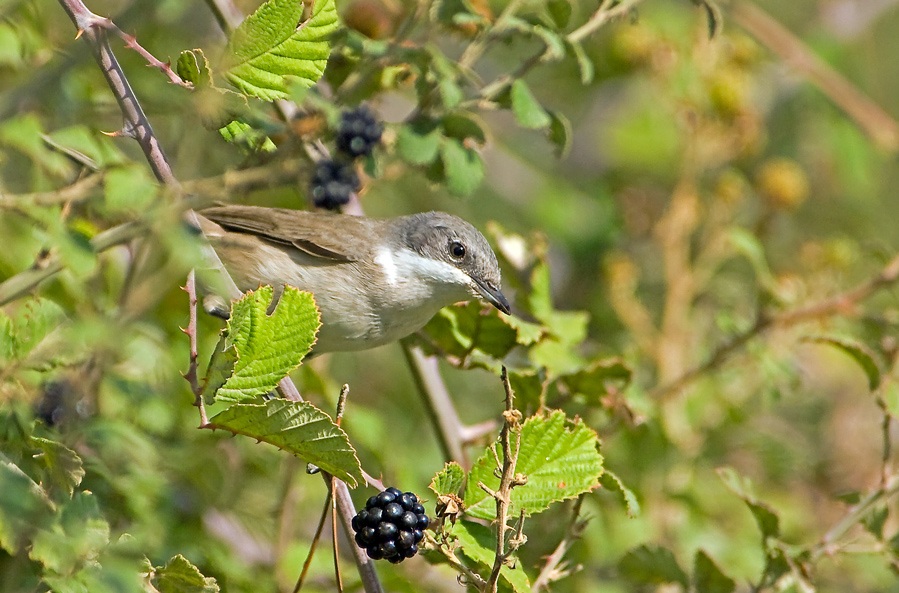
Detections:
[225, 0, 338, 101]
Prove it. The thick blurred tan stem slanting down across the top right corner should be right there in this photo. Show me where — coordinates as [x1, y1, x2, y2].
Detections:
[732, 2, 899, 151]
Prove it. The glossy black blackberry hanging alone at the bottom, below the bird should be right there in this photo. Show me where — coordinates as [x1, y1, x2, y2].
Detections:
[353, 487, 430, 564]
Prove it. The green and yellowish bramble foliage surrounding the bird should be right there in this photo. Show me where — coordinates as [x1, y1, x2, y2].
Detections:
[0, 0, 899, 593]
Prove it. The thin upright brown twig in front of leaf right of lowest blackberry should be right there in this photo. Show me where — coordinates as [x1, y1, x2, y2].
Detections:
[488, 367, 527, 593]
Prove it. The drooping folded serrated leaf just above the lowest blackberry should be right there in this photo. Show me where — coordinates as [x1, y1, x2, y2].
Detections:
[209, 399, 362, 488]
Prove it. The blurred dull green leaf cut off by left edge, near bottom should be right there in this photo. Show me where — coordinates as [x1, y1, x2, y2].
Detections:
[0, 454, 55, 554]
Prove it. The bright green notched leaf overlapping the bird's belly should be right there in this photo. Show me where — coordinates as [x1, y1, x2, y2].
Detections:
[207, 286, 321, 401]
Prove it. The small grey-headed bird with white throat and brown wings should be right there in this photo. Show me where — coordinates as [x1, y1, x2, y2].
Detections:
[199, 205, 511, 354]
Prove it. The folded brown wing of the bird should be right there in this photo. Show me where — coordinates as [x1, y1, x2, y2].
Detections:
[200, 205, 363, 262]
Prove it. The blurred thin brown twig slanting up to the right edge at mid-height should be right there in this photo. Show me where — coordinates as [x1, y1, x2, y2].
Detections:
[652, 250, 899, 398]
